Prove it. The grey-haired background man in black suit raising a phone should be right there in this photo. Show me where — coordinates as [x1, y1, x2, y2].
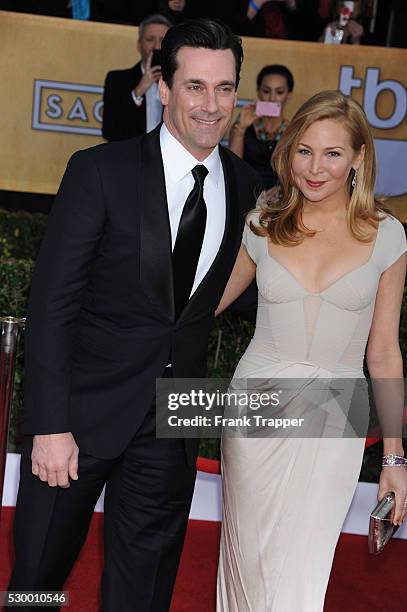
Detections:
[102, 15, 171, 141]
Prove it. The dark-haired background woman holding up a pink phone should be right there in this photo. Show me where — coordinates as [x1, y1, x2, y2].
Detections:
[229, 64, 294, 189]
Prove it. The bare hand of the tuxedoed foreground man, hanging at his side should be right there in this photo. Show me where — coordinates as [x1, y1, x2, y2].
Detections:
[31, 432, 79, 488]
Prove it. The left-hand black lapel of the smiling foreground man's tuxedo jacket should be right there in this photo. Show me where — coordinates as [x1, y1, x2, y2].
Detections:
[139, 126, 174, 321]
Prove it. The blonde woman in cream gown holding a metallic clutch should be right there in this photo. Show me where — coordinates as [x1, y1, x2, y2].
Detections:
[217, 91, 407, 612]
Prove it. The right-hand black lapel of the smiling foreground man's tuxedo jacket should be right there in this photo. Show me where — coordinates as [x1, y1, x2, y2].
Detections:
[179, 147, 240, 319]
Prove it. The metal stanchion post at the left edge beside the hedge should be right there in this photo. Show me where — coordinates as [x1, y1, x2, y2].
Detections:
[0, 317, 25, 517]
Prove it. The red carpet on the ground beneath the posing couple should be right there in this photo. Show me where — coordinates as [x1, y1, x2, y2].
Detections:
[0, 508, 407, 612]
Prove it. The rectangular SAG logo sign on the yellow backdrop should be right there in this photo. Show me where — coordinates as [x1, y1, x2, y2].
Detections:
[32, 79, 103, 136]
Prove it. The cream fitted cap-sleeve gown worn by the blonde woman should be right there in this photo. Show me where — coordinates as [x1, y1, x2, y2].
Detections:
[217, 216, 407, 612]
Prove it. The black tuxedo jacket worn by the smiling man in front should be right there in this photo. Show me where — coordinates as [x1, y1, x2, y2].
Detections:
[24, 128, 259, 458]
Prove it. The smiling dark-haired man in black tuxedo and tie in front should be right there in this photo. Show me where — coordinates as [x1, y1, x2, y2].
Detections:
[9, 20, 260, 612]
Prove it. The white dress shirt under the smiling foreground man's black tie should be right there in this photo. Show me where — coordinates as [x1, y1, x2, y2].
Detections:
[160, 124, 226, 295]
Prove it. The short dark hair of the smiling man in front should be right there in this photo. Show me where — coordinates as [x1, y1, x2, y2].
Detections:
[161, 19, 243, 88]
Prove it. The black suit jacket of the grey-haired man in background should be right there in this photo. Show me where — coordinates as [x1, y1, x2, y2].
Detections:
[102, 62, 146, 141]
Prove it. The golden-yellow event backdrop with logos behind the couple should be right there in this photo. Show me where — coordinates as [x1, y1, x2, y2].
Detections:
[0, 11, 407, 222]
